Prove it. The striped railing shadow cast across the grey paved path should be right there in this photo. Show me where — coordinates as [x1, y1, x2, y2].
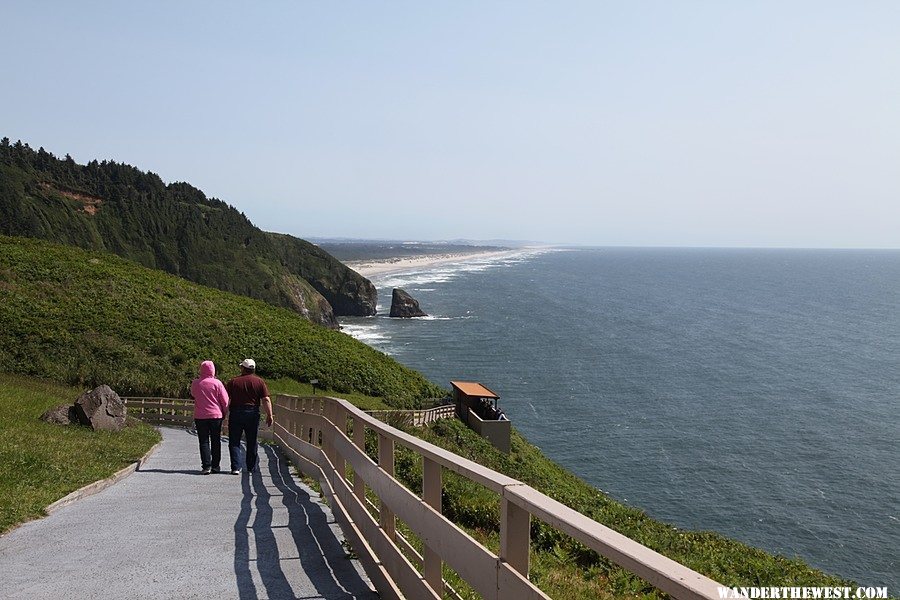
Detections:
[234, 445, 378, 600]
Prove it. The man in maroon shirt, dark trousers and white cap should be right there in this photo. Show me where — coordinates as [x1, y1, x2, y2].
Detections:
[225, 358, 274, 475]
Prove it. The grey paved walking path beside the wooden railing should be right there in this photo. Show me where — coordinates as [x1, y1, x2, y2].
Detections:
[0, 429, 377, 600]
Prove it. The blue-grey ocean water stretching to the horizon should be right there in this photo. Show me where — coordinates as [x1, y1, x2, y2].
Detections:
[343, 249, 900, 594]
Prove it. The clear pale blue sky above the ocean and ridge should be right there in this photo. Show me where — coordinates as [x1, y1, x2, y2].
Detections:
[0, 0, 900, 248]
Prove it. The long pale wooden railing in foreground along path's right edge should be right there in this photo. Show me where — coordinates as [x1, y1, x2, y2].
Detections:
[274, 396, 720, 600]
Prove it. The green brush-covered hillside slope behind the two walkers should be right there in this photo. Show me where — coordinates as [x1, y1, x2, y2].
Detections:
[0, 236, 444, 407]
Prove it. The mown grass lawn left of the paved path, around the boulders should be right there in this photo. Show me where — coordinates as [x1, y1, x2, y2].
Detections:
[0, 375, 161, 533]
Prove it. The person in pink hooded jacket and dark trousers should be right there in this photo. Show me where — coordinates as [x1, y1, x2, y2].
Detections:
[191, 360, 228, 475]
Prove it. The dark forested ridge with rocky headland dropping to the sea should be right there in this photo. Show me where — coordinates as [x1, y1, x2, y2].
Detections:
[0, 138, 376, 327]
